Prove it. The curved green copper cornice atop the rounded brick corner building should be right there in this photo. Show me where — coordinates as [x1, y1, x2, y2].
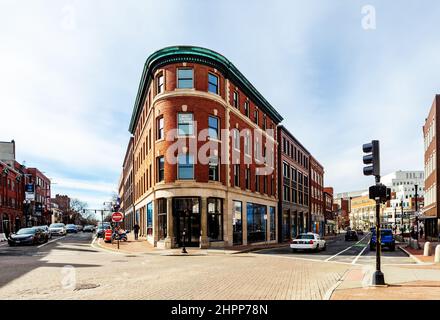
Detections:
[129, 46, 283, 133]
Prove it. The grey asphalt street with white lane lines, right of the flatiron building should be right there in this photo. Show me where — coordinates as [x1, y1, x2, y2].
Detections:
[257, 233, 415, 265]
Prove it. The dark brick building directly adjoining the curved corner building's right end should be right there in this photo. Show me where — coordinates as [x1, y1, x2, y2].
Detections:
[278, 126, 310, 242]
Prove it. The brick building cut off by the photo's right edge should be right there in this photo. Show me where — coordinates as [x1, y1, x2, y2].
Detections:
[420, 95, 440, 241]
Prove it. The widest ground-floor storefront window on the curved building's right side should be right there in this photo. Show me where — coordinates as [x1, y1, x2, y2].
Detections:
[247, 203, 267, 243]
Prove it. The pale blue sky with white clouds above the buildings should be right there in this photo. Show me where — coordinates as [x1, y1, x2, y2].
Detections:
[0, 0, 440, 209]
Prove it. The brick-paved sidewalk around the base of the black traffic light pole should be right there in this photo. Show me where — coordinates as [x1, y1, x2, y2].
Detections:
[331, 265, 440, 300]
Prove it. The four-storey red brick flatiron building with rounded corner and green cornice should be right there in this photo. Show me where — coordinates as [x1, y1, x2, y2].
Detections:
[121, 46, 282, 248]
